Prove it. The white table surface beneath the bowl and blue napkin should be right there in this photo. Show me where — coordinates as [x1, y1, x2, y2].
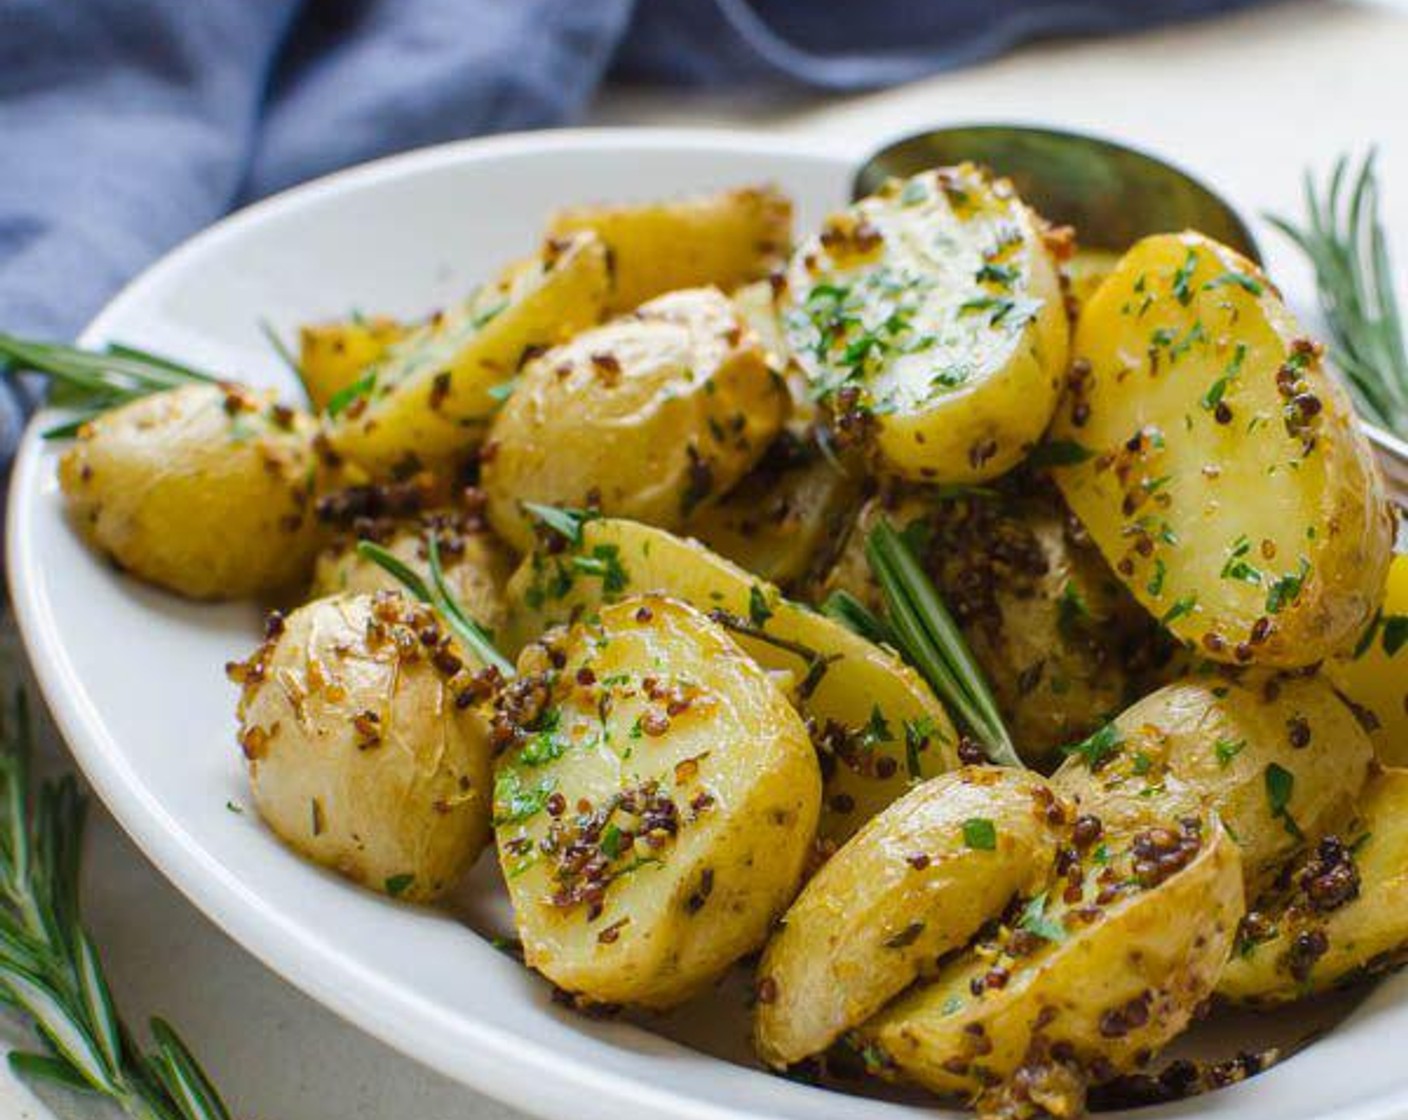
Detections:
[0, 0, 1408, 1120]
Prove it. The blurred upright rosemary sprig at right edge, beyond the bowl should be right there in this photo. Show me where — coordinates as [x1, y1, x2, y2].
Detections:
[1267, 149, 1408, 433]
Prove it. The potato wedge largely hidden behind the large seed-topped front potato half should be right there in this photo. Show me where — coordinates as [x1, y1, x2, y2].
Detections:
[504, 518, 957, 842]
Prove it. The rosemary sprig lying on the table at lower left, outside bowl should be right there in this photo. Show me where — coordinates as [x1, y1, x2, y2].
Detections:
[0, 690, 230, 1120]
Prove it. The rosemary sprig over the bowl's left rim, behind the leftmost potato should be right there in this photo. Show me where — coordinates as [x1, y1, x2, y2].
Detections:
[0, 332, 218, 440]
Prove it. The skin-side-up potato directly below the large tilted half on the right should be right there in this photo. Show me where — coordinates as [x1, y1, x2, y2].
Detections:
[1052, 676, 1373, 896]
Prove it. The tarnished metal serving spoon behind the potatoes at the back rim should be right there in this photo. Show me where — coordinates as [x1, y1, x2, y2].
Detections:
[852, 124, 1408, 506]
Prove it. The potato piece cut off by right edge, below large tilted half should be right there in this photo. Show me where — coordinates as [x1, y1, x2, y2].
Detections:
[1325, 555, 1408, 766]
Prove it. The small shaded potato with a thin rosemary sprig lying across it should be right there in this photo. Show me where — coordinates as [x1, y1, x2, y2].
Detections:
[308, 509, 514, 634]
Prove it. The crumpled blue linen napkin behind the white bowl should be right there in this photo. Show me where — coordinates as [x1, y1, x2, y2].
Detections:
[0, 0, 1272, 466]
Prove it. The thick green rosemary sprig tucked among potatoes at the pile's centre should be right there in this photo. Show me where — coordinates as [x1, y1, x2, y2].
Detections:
[861, 518, 1022, 766]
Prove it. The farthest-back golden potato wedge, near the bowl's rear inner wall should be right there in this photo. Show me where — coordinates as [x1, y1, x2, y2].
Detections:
[548, 186, 791, 314]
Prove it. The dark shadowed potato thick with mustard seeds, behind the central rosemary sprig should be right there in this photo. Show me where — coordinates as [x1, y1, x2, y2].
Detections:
[821, 475, 1173, 766]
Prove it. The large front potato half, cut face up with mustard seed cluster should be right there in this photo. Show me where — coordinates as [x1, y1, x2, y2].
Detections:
[494, 596, 821, 1007]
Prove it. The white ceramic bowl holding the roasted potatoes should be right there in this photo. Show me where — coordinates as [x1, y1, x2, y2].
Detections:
[7, 131, 1408, 1120]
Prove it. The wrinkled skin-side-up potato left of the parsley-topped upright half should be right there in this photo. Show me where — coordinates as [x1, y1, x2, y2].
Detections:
[482, 289, 787, 551]
